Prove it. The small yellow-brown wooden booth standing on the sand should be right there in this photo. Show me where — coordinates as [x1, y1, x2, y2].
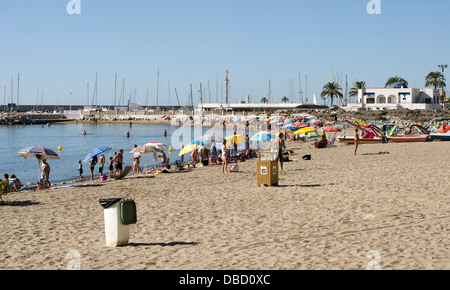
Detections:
[256, 151, 278, 186]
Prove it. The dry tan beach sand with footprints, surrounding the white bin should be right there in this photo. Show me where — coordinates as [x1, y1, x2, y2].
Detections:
[0, 142, 450, 270]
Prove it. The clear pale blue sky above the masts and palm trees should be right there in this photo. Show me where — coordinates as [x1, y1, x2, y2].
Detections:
[0, 0, 450, 105]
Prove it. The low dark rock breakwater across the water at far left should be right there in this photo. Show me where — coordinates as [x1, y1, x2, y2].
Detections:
[0, 113, 67, 125]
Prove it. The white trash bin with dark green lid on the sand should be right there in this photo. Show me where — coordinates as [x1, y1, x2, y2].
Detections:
[100, 198, 136, 247]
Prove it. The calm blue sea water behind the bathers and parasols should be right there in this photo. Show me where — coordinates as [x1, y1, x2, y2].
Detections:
[0, 124, 225, 185]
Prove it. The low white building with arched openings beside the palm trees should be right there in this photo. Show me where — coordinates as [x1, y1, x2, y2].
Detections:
[347, 83, 442, 111]
